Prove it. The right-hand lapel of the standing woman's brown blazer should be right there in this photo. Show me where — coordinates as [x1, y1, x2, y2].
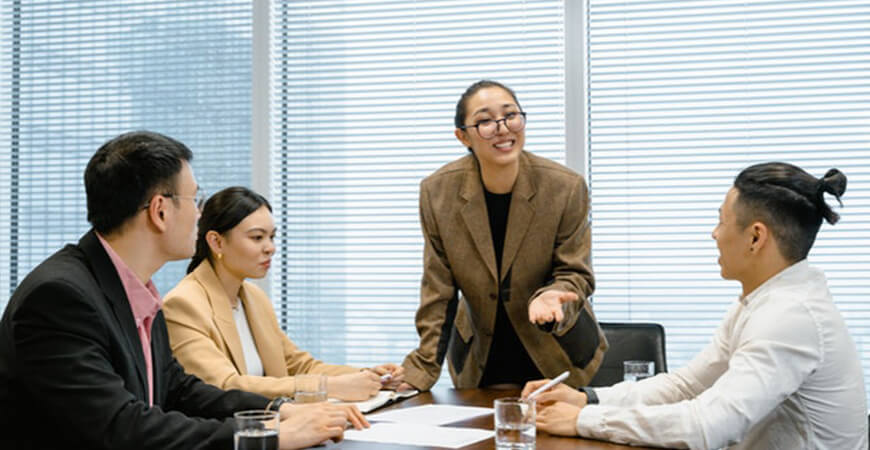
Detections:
[499, 153, 537, 281]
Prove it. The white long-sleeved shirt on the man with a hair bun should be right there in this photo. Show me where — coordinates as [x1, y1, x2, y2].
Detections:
[577, 260, 867, 450]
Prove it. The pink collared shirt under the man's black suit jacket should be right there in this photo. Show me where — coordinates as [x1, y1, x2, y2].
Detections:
[96, 233, 163, 406]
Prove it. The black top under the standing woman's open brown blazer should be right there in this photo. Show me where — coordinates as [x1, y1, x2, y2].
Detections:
[480, 189, 543, 387]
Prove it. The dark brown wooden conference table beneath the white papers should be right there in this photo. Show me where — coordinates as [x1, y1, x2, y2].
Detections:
[330, 389, 660, 450]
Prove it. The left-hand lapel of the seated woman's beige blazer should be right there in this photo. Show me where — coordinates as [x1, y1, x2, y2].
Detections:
[193, 260, 248, 375]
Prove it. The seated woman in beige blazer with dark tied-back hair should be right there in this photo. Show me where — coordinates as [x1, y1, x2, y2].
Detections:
[163, 187, 404, 401]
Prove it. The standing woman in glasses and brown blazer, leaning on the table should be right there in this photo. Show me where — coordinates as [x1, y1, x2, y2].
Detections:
[402, 80, 607, 389]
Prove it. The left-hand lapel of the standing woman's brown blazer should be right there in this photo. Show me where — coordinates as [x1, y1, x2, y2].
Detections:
[460, 157, 500, 280]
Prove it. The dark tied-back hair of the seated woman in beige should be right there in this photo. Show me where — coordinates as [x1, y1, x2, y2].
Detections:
[187, 186, 272, 273]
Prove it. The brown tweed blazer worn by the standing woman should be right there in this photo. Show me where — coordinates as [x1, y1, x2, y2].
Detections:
[402, 152, 607, 389]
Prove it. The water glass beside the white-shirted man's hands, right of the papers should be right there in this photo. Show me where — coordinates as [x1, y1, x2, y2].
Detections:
[494, 397, 535, 450]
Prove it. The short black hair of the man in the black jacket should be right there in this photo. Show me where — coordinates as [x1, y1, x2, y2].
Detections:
[85, 131, 193, 234]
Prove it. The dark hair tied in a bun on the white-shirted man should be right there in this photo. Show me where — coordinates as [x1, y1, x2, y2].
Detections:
[734, 162, 846, 262]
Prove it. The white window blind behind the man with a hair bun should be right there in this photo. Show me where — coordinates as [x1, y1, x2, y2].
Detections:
[587, 0, 870, 404]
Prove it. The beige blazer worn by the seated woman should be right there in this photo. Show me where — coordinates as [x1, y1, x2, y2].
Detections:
[163, 260, 359, 397]
